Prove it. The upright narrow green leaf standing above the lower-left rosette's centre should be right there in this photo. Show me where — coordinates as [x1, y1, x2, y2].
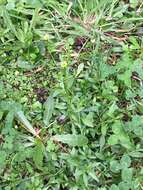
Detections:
[43, 96, 54, 126]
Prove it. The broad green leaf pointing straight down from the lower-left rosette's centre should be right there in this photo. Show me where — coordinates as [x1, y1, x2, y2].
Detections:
[33, 139, 44, 169]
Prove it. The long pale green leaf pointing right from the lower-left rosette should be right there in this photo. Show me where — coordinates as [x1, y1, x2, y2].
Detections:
[52, 134, 88, 146]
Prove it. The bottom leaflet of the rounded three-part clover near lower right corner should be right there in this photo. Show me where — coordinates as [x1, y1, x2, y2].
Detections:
[121, 168, 133, 182]
